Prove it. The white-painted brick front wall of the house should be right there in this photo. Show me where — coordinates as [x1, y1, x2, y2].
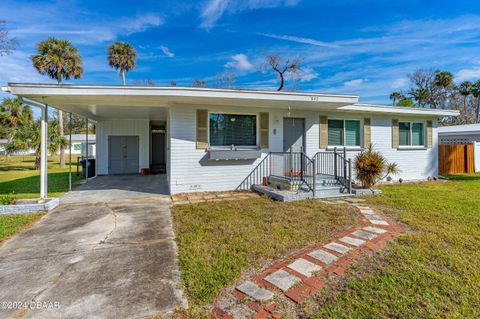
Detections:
[169, 106, 438, 194]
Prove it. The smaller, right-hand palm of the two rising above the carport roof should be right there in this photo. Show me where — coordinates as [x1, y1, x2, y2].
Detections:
[107, 41, 137, 85]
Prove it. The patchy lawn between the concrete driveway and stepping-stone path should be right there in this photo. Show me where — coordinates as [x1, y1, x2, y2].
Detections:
[173, 198, 359, 306]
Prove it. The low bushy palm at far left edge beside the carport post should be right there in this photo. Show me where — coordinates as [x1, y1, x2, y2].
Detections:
[0, 98, 33, 161]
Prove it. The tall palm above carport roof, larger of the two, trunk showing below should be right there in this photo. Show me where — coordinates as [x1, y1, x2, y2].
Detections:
[32, 38, 83, 167]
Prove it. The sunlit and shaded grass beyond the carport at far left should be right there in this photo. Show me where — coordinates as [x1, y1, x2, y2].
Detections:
[0, 156, 80, 199]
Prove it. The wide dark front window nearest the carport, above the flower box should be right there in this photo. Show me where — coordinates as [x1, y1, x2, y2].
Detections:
[209, 113, 257, 146]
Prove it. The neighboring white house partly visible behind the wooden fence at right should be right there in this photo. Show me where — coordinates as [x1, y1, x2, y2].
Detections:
[438, 123, 480, 172]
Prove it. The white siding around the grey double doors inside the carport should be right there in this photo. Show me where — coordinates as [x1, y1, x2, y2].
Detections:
[96, 120, 150, 175]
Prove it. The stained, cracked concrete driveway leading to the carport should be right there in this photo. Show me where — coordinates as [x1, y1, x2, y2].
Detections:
[0, 177, 186, 318]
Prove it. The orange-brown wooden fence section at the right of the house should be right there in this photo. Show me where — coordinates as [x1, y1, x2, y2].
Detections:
[438, 144, 475, 174]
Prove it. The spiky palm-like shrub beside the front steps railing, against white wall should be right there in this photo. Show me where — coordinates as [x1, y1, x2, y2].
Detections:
[353, 144, 400, 188]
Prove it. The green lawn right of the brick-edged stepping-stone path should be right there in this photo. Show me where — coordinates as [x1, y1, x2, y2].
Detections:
[302, 174, 480, 318]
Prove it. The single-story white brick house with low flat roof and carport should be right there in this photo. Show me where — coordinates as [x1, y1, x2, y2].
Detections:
[3, 83, 458, 199]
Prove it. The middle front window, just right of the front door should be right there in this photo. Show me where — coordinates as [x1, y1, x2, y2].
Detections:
[328, 120, 360, 146]
